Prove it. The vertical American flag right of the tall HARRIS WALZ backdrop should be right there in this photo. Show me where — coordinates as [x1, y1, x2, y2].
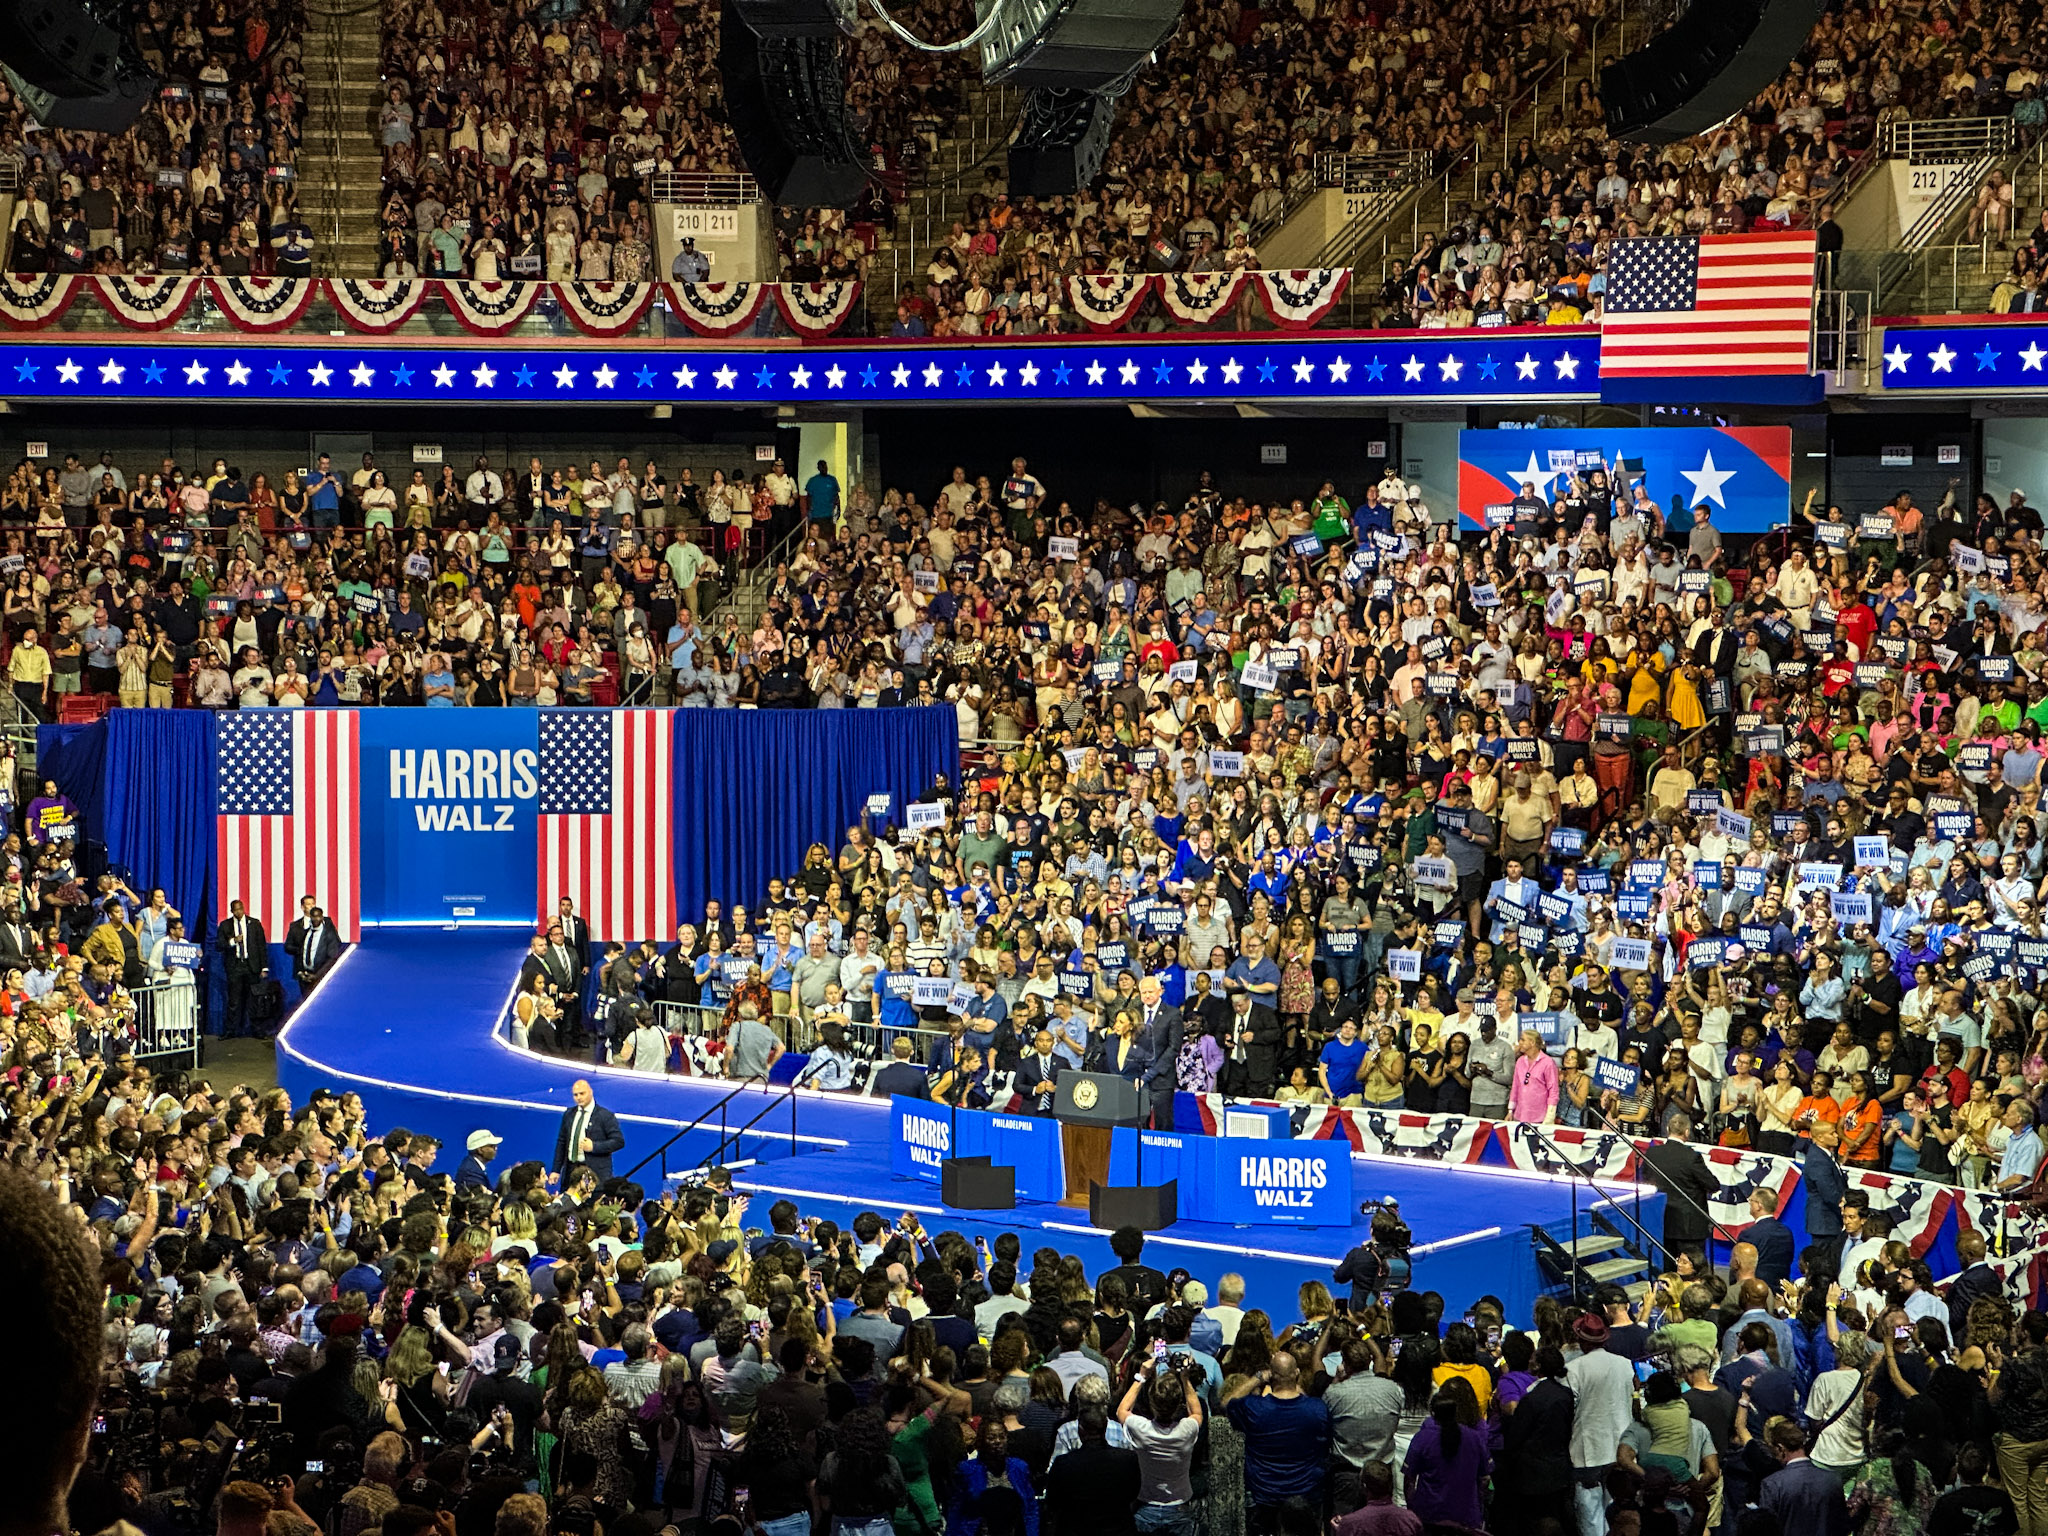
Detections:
[539, 709, 676, 940]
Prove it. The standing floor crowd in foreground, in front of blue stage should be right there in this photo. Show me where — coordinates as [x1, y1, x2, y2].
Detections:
[0, 1047, 2048, 1536]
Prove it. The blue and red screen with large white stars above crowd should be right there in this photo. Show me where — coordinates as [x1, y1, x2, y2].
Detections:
[1458, 426, 1792, 532]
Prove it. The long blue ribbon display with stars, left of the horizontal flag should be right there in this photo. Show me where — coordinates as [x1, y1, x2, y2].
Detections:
[0, 332, 1599, 406]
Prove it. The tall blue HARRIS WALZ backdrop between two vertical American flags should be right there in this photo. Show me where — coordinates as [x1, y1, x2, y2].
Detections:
[358, 709, 541, 924]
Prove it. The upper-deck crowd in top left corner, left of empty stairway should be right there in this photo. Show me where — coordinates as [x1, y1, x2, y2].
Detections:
[0, 0, 313, 276]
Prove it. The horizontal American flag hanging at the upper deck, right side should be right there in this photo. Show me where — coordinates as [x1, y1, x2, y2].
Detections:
[1599, 229, 1815, 379]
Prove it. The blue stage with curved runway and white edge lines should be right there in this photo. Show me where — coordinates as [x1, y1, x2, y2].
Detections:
[279, 928, 1663, 1327]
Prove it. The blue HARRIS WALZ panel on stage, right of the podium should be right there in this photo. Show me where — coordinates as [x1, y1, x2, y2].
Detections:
[1114, 1128, 1358, 1227]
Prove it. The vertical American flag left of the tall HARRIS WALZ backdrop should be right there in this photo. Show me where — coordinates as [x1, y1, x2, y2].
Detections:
[215, 709, 362, 942]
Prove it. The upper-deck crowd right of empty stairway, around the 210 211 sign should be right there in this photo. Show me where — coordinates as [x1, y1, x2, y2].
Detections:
[377, 0, 973, 283]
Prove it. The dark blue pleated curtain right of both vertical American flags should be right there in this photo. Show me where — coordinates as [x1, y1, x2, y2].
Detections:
[672, 705, 961, 922]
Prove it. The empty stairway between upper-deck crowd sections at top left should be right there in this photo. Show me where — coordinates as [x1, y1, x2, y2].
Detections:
[299, 0, 383, 276]
